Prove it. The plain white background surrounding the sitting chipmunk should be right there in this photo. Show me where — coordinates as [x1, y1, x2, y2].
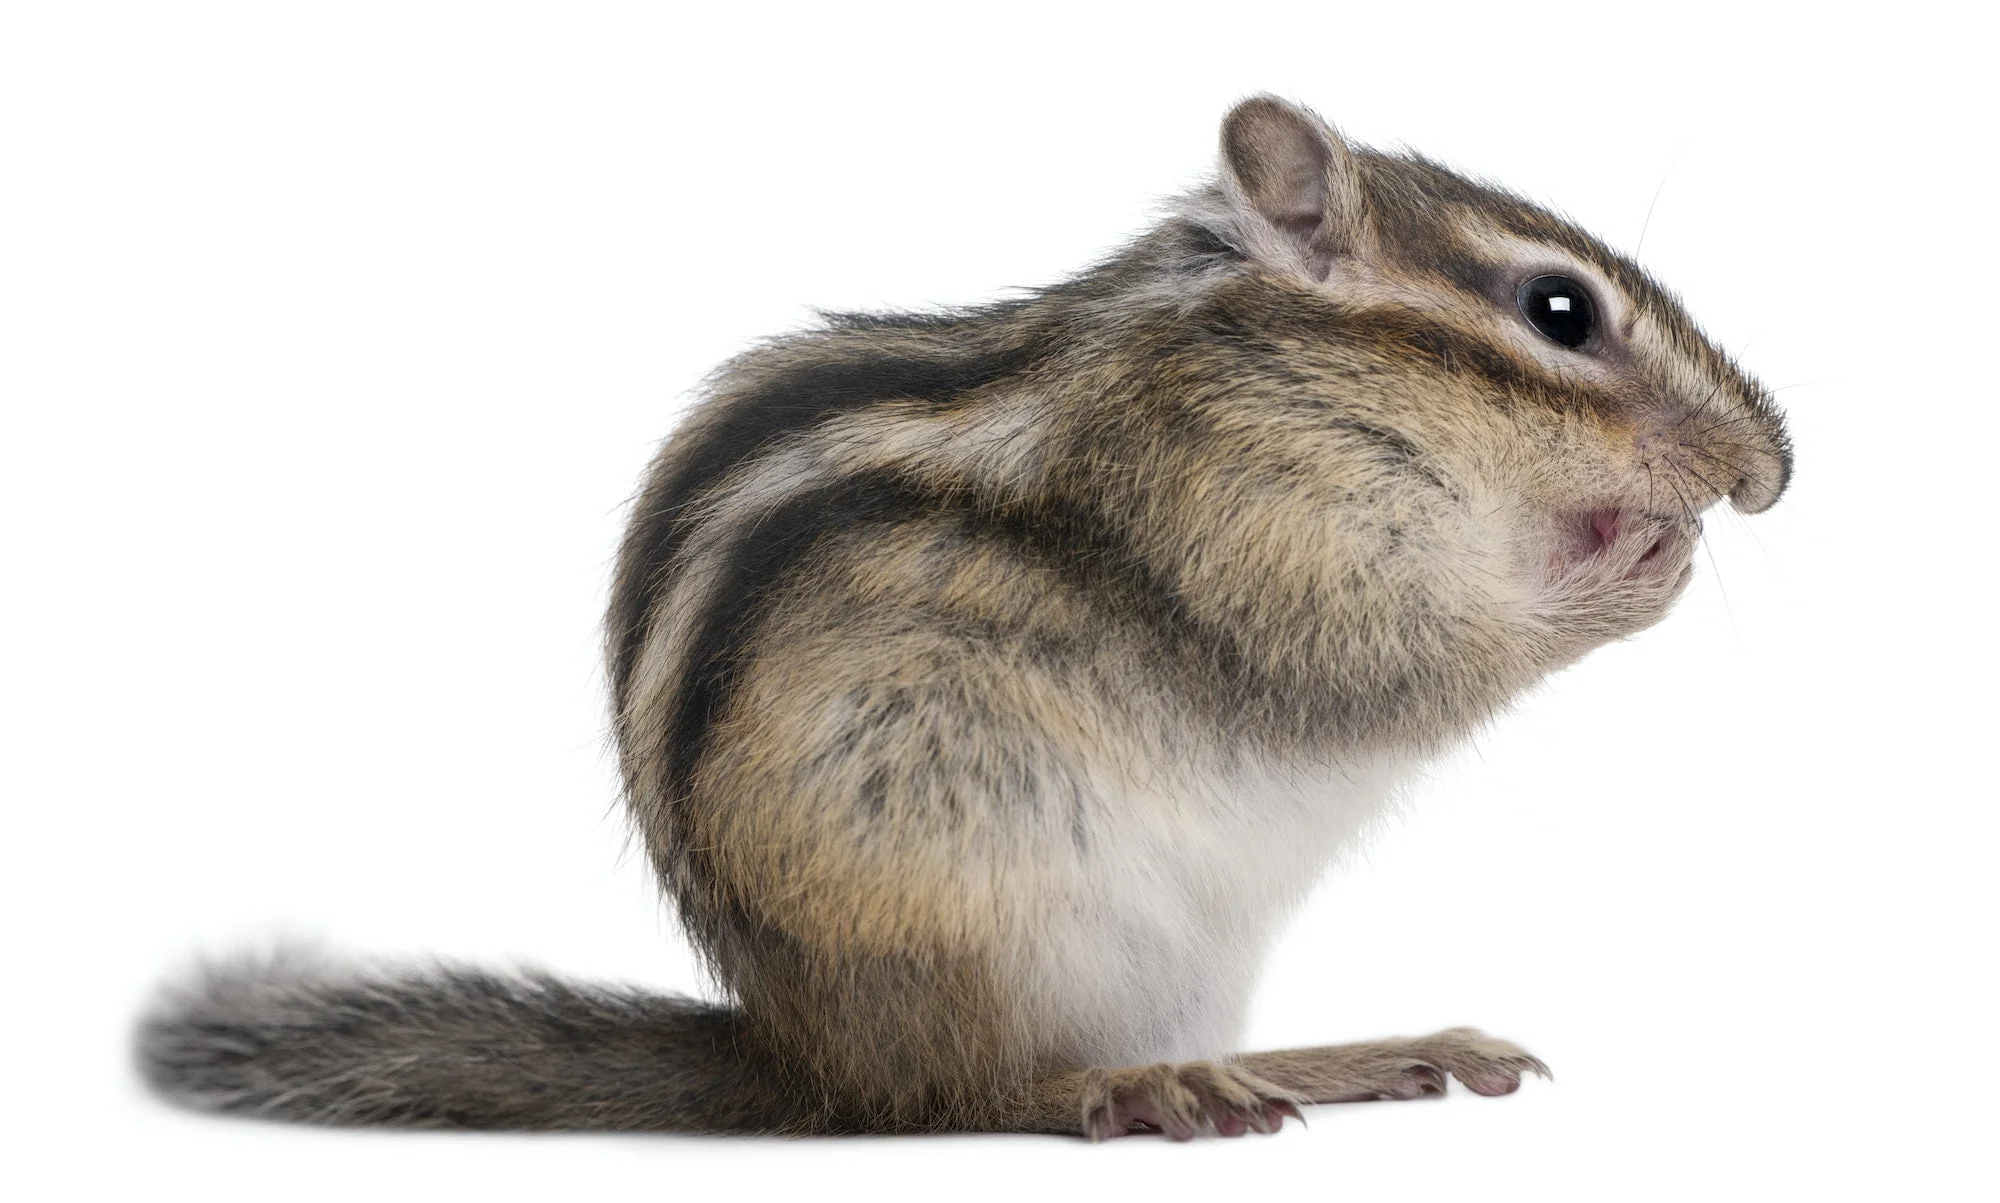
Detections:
[0, 2, 2000, 1199]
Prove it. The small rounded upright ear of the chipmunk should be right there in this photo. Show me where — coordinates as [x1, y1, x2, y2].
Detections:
[1222, 96, 1374, 280]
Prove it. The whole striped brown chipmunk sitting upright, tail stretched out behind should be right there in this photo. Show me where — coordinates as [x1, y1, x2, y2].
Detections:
[138, 96, 1792, 1139]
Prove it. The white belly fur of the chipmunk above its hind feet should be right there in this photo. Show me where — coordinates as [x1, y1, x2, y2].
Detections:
[1018, 743, 1414, 1065]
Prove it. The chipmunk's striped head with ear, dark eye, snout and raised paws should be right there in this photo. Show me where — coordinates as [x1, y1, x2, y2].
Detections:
[1202, 98, 1792, 643]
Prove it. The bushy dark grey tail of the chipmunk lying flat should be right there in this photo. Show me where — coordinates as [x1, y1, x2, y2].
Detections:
[138, 953, 798, 1131]
